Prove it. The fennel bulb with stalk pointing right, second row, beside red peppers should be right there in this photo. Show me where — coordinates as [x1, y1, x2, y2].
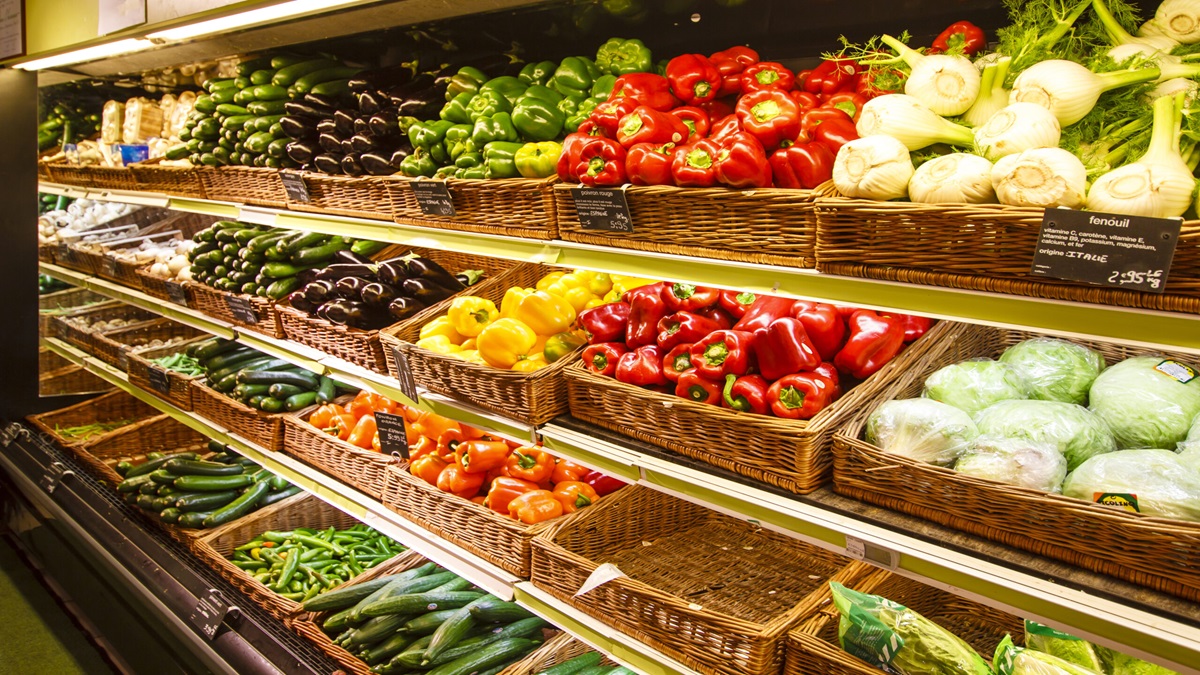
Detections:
[854, 94, 974, 150]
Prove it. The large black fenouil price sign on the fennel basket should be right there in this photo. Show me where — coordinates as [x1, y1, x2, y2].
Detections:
[1030, 209, 1183, 293]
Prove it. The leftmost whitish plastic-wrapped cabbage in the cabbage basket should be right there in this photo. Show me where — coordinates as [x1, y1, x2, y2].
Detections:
[866, 399, 979, 466]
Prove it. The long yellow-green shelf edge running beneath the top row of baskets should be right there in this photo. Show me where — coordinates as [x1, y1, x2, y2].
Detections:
[40, 183, 1200, 354]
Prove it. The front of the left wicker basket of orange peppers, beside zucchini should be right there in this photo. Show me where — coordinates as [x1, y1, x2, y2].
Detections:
[283, 408, 396, 500]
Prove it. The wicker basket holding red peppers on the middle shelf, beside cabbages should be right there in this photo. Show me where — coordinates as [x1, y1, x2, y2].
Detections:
[566, 321, 962, 495]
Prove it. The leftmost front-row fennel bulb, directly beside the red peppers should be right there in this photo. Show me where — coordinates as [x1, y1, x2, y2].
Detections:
[833, 135, 913, 201]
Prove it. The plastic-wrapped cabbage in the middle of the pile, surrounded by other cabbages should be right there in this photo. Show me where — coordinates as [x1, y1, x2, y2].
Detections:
[974, 401, 1117, 471]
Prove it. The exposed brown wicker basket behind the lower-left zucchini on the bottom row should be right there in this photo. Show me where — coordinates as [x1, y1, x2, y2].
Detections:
[72, 414, 209, 485]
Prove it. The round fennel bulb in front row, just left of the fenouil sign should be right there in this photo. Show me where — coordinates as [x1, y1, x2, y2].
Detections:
[991, 148, 1087, 209]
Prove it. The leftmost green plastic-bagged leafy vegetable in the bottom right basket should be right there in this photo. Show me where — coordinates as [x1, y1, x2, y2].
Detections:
[829, 581, 991, 675]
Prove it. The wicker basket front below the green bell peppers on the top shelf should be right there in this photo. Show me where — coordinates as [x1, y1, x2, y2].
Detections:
[382, 177, 558, 239]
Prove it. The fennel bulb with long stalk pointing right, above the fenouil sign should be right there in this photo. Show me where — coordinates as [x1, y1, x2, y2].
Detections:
[1008, 59, 1159, 126]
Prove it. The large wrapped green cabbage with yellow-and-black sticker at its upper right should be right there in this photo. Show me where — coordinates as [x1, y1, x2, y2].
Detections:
[1088, 357, 1200, 448]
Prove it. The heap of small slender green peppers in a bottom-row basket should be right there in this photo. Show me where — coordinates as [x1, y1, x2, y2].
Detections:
[232, 524, 404, 602]
